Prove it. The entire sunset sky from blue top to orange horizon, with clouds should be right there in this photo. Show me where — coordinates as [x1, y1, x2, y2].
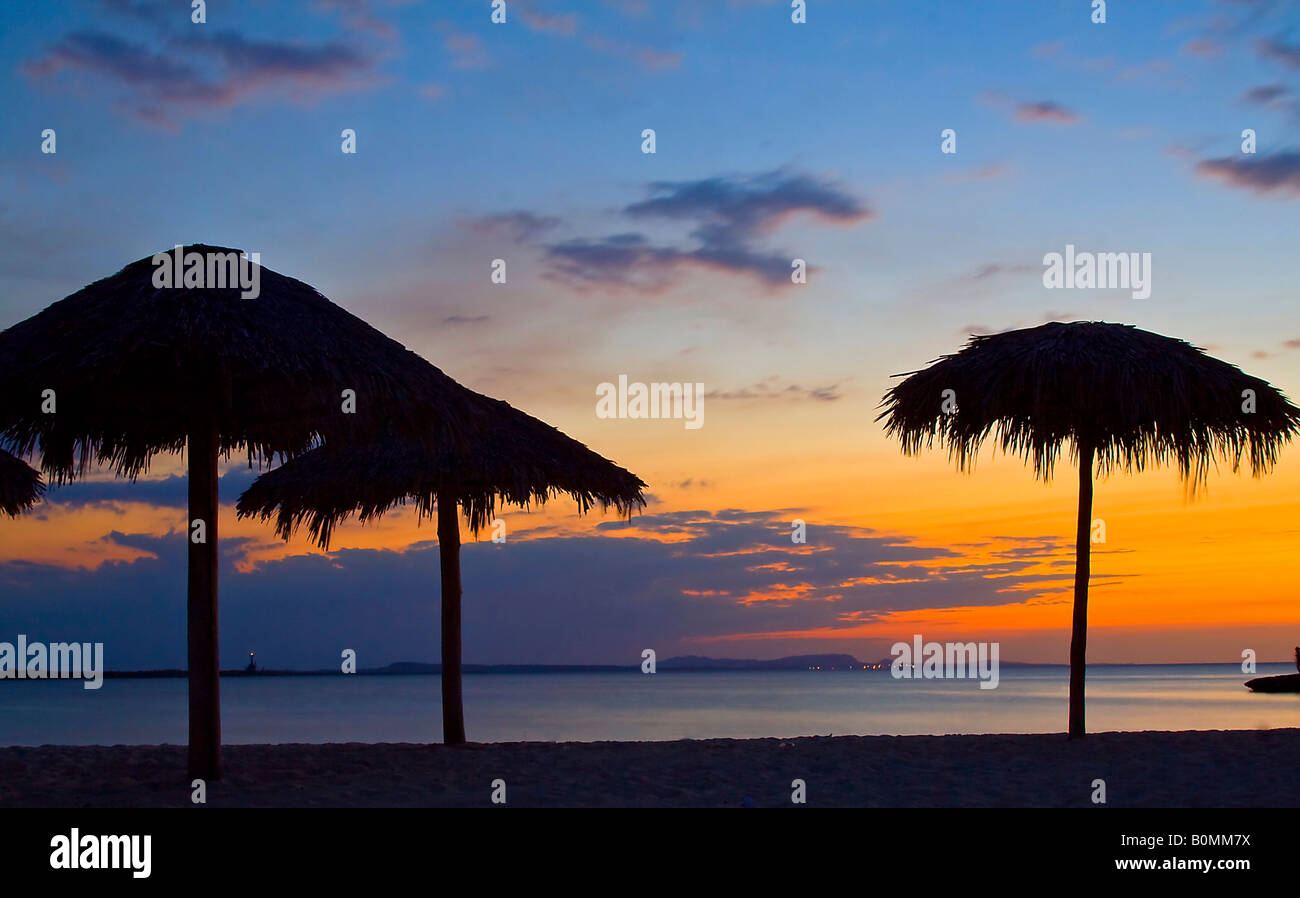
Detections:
[0, 0, 1300, 669]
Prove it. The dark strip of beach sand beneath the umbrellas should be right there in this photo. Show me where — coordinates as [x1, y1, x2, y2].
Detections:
[0, 729, 1300, 807]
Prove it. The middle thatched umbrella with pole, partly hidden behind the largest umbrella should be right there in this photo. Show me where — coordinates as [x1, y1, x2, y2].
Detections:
[238, 394, 645, 745]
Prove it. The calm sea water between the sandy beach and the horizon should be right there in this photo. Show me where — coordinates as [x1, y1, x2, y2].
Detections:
[0, 664, 1300, 746]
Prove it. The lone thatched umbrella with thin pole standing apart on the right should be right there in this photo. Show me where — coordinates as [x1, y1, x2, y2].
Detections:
[876, 321, 1300, 737]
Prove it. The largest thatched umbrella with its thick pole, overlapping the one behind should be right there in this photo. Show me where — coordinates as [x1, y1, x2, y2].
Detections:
[0, 244, 483, 778]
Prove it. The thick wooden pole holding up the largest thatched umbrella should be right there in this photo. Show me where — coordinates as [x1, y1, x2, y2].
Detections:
[187, 424, 221, 780]
